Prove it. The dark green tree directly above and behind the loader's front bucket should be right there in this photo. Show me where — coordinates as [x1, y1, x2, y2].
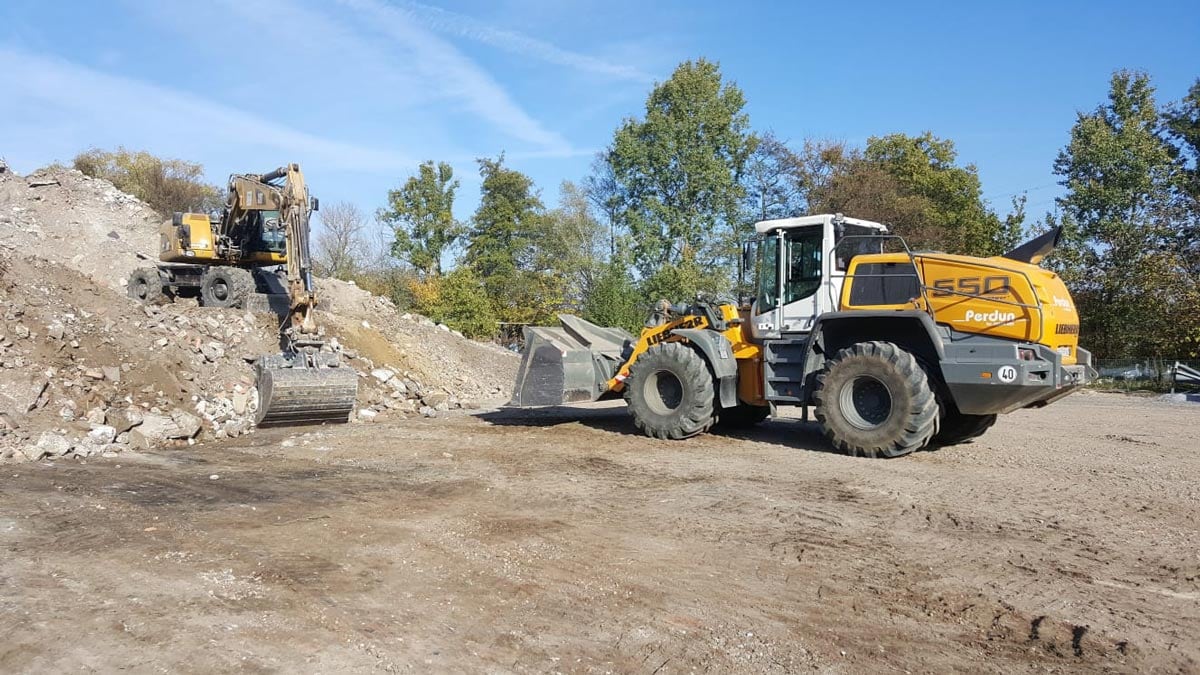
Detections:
[464, 155, 564, 323]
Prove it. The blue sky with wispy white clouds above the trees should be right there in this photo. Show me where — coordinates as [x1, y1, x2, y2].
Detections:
[0, 0, 1200, 234]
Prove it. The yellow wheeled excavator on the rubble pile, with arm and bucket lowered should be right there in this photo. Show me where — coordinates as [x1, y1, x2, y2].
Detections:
[128, 163, 358, 426]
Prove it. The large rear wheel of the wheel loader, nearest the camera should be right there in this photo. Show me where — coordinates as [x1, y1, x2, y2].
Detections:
[815, 342, 938, 458]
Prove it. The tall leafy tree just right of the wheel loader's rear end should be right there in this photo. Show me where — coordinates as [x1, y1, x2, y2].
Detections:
[1055, 71, 1200, 357]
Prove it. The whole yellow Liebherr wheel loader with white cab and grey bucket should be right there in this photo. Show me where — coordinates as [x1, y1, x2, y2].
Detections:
[512, 214, 1096, 458]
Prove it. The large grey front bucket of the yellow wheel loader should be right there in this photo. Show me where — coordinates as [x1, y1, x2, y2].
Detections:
[509, 315, 634, 407]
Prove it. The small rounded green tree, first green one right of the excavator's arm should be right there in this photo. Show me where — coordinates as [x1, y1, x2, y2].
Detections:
[378, 160, 464, 276]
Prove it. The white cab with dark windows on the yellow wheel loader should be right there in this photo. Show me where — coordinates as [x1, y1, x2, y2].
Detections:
[749, 214, 888, 341]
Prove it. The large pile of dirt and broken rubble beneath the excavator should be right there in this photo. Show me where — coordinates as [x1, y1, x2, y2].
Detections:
[0, 163, 517, 461]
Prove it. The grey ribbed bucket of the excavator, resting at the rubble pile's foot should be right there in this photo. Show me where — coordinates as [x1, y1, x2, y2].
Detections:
[254, 353, 359, 426]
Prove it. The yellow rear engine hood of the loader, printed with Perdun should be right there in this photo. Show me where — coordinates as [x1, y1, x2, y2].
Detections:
[839, 253, 1079, 365]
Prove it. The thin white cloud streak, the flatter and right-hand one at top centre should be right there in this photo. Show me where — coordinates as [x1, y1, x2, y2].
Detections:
[403, 2, 654, 84]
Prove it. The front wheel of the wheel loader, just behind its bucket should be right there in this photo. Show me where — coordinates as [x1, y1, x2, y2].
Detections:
[625, 342, 715, 440]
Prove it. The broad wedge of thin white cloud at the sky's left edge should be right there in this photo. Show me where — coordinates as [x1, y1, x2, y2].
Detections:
[0, 47, 414, 171]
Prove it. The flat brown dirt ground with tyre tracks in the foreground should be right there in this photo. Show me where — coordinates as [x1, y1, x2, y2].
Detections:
[0, 393, 1200, 673]
